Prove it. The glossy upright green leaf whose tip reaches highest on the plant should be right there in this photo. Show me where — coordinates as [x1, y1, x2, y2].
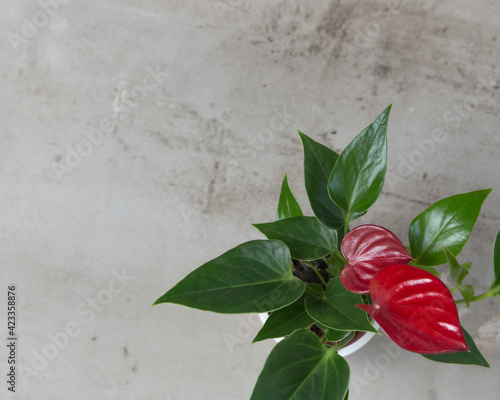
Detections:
[328, 106, 391, 219]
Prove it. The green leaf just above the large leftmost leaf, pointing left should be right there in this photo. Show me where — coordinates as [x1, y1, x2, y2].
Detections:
[254, 217, 337, 261]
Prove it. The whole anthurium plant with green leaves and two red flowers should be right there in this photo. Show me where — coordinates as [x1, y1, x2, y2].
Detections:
[155, 106, 500, 400]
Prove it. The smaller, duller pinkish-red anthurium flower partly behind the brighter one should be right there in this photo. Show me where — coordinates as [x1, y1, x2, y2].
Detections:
[340, 225, 413, 294]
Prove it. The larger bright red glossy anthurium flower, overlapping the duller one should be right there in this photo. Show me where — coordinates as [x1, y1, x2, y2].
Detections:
[358, 265, 468, 354]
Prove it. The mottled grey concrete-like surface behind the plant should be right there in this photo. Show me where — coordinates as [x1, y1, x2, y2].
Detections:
[0, 0, 500, 400]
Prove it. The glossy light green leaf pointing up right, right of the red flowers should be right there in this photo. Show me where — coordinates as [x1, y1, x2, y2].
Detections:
[409, 189, 492, 266]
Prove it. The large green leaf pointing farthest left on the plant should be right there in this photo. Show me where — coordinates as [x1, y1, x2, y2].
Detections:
[154, 240, 306, 314]
